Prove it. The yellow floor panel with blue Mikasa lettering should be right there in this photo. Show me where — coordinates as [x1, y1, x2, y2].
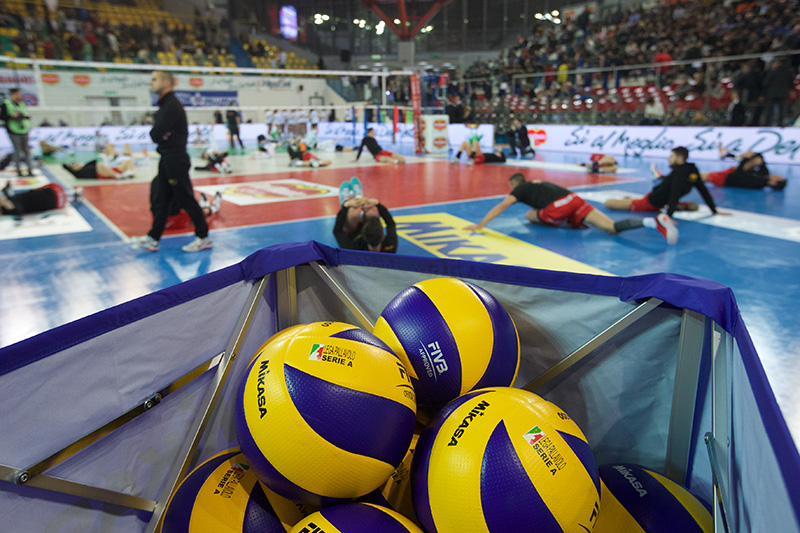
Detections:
[394, 213, 611, 275]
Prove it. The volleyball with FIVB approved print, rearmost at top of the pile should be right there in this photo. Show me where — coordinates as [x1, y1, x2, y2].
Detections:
[373, 278, 520, 407]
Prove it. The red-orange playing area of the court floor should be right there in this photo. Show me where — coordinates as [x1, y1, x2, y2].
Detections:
[84, 161, 628, 236]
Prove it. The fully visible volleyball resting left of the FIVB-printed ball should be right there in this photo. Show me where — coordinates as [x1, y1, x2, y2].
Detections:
[234, 322, 416, 505]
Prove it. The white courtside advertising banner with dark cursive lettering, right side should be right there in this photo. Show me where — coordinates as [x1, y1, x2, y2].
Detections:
[527, 124, 800, 163]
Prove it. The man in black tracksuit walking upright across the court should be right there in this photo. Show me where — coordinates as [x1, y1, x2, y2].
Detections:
[132, 71, 213, 252]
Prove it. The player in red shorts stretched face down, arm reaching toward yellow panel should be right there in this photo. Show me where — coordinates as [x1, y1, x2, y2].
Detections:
[464, 173, 678, 244]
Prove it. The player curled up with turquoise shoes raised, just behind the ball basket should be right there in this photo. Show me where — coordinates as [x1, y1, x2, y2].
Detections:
[333, 177, 397, 253]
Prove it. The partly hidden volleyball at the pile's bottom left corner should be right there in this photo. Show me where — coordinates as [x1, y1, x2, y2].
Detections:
[161, 448, 308, 533]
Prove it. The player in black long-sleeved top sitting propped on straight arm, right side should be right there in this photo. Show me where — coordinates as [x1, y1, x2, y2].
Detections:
[605, 146, 728, 217]
